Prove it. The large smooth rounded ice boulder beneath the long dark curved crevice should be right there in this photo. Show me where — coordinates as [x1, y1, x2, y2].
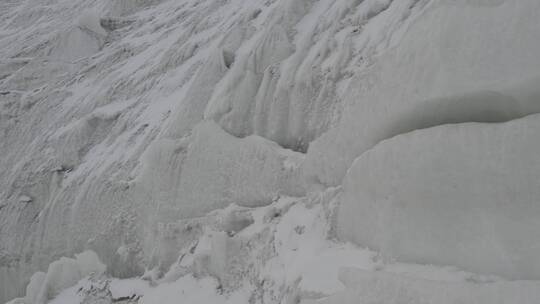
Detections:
[337, 115, 540, 279]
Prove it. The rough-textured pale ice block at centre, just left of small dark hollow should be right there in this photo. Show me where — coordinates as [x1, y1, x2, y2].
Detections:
[136, 121, 304, 227]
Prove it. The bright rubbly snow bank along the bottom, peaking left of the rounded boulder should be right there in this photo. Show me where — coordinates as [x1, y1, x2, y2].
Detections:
[8, 195, 538, 304]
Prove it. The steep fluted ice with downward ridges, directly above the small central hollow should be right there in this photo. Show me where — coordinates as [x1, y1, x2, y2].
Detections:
[205, 1, 400, 151]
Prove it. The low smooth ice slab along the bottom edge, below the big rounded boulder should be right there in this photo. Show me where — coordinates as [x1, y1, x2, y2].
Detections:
[301, 268, 540, 304]
